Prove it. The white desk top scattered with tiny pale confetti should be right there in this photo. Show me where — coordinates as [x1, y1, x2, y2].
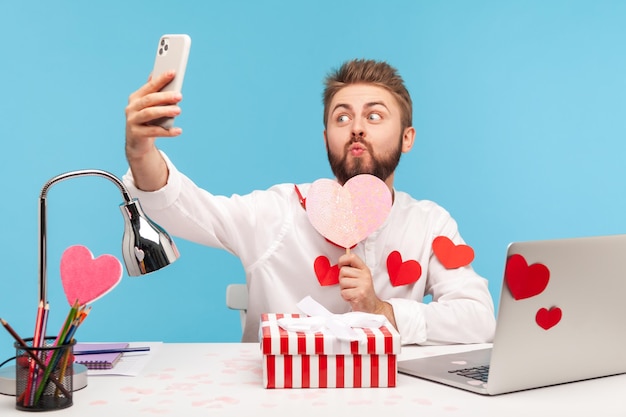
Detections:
[0, 343, 626, 417]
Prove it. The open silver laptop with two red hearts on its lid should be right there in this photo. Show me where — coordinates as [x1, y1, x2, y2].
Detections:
[398, 235, 626, 395]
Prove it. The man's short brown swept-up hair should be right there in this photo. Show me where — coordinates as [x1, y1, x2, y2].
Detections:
[324, 59, 413, 130]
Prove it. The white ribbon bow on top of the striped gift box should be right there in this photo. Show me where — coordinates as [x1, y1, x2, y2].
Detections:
[278, 296, 387, 342]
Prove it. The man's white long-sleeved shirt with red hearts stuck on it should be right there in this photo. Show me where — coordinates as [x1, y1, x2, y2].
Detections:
[124, 154, 495, 344]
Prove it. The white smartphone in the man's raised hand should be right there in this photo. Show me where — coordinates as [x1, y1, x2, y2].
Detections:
[150, 34, 191, 129]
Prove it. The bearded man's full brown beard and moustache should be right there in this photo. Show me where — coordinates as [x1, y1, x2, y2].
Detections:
[326, 138, 402, 185]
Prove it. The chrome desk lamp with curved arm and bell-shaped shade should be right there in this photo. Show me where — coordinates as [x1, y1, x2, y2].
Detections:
[0, 169, 180, 395]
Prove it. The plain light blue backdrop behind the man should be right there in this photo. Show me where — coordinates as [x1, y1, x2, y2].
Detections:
[0, 0, 626, 360]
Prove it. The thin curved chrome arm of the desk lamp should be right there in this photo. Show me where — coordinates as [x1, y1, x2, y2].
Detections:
[39, 169, 132, 303]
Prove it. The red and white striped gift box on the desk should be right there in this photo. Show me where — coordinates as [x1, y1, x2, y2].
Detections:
[260, 314, 400, 388]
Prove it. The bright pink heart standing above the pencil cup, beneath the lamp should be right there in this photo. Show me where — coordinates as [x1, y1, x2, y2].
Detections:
[61, 245, 122, 305]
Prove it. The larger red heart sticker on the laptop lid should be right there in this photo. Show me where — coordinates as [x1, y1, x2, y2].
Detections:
[504, 254, 550, 300]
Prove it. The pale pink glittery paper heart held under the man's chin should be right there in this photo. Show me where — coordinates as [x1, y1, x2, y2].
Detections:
[306, 174, 391, 248]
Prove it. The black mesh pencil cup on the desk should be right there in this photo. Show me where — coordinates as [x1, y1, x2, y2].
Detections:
[15, 337, 76, 411]
